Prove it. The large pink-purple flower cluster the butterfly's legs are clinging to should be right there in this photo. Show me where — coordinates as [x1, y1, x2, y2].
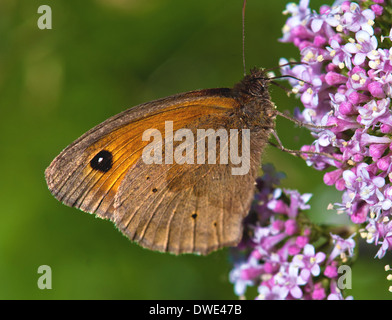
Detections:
[280, 0, 392, 258]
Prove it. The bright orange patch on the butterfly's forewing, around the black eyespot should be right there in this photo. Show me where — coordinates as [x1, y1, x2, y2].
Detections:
[76, 97, 236, 214]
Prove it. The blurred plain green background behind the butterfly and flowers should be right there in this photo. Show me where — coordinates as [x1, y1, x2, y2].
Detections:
[0, 0, 392, 299]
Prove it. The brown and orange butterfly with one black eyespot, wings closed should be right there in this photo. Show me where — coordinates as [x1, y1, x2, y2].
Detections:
[45, 69, 276, 254]
